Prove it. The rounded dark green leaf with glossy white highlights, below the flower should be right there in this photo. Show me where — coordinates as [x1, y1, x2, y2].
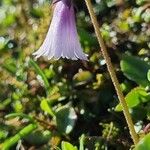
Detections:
[56, 105, 77, 134]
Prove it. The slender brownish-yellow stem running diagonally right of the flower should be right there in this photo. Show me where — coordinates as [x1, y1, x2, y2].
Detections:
[85, 0, 139, 144]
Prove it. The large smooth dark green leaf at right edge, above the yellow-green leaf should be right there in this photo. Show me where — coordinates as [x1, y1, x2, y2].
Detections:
[120, 55, 150, 87]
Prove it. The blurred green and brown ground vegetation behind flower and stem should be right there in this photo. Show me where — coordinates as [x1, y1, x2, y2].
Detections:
[0, 0, 150, 150]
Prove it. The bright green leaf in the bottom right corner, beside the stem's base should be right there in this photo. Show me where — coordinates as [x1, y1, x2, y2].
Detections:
[134, 134, 150, 150]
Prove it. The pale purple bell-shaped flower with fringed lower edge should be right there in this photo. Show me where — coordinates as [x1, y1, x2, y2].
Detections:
[33, 0, 87, 60]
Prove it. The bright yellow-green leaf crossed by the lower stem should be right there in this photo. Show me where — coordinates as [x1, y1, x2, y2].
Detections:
[115, 87, 150, 111]
